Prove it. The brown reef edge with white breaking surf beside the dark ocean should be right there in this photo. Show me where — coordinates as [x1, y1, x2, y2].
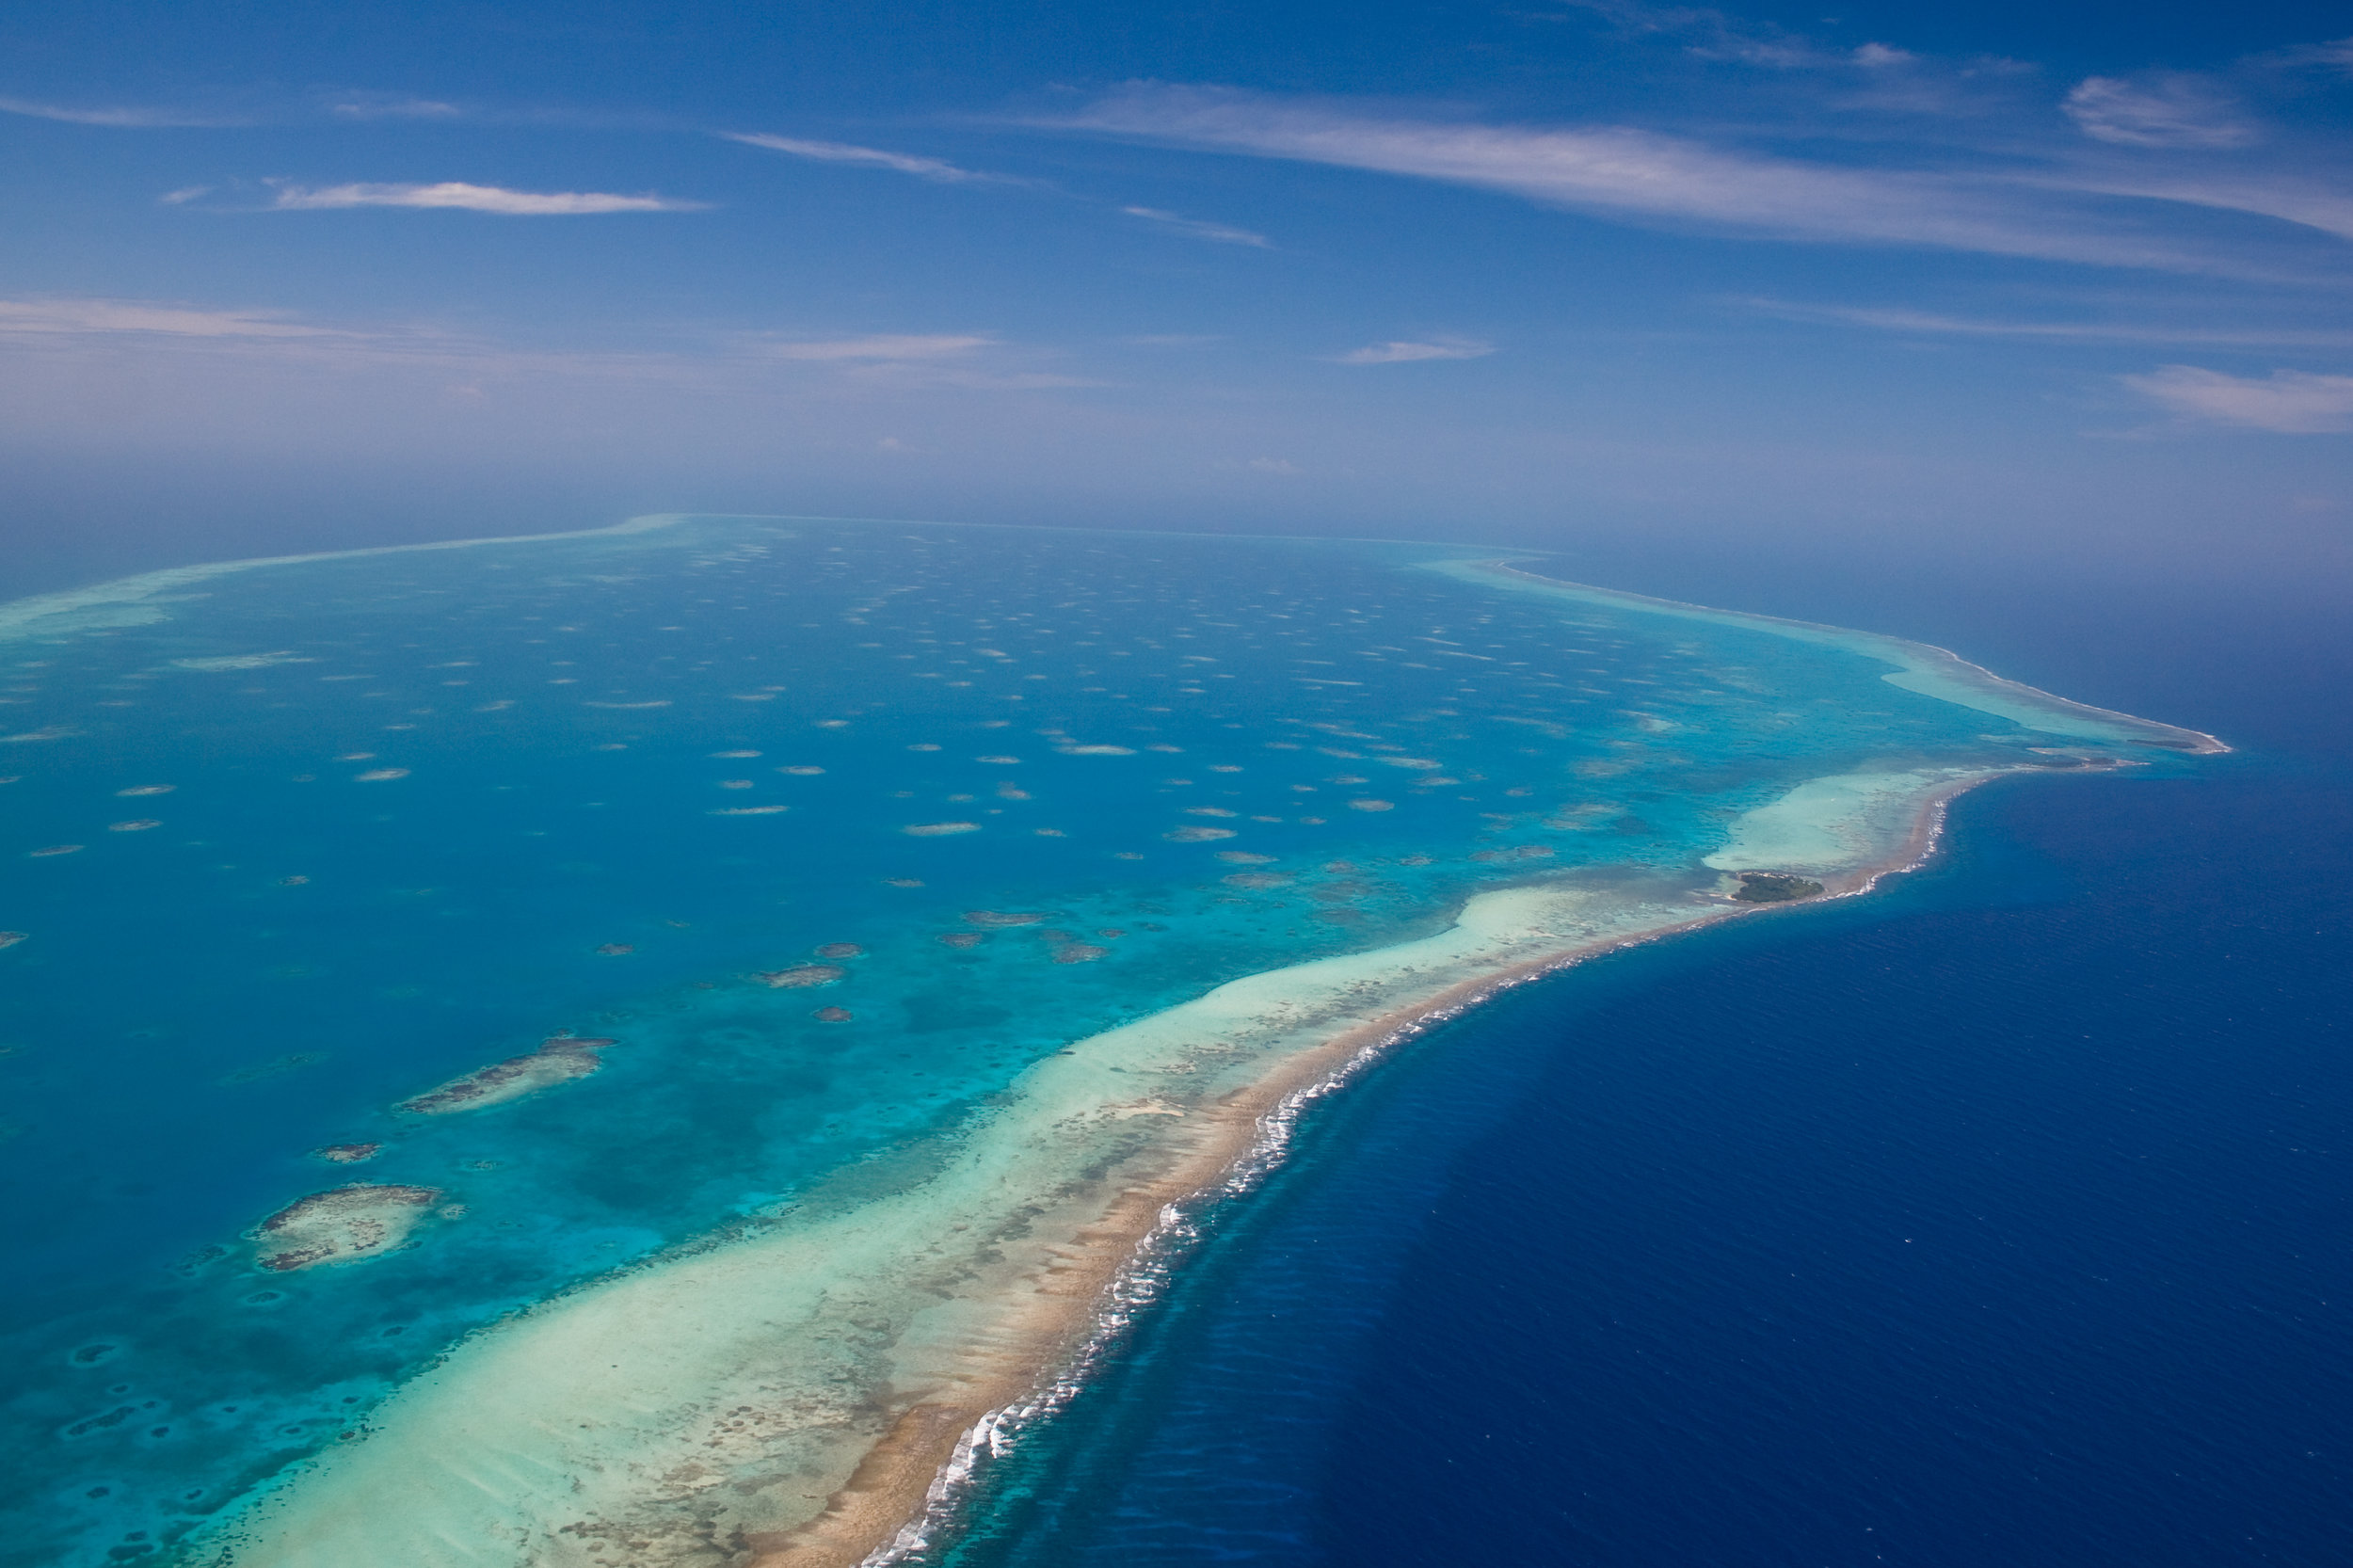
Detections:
[744, 770, 2005, 1568]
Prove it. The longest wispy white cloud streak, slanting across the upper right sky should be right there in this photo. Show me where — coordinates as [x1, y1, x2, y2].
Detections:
[1043, 85, 2233, 271]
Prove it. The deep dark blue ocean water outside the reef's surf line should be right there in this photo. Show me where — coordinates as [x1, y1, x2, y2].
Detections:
[941, 584, 2353, 1568]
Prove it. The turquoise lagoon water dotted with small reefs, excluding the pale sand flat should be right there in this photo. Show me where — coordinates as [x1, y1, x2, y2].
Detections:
[0, 518, 2202, 1563]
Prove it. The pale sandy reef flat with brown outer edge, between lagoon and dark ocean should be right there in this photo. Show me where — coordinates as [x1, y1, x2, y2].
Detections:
[200, 753, 2024, 1568]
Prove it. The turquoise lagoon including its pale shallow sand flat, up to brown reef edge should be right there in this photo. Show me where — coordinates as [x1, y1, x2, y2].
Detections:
[0, 518, 2202, 1568]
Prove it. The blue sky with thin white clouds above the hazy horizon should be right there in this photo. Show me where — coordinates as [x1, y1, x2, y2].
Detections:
[0, 0, 2353, 591]
